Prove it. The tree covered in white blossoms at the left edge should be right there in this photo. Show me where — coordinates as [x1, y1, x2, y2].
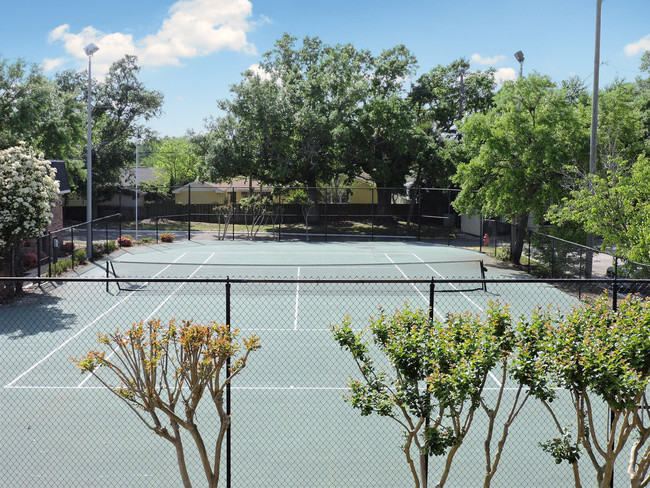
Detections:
[0, 144, 59, 290]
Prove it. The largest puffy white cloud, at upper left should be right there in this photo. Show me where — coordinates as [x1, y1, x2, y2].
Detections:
[49, 0, 256, 75]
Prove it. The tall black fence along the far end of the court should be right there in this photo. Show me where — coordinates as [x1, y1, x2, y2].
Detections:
[64, 185, 460, 240]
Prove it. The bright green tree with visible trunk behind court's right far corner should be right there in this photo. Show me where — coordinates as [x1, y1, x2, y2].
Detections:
[453, 73, 589, 264]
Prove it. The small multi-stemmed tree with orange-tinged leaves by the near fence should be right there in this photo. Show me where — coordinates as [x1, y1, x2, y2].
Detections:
[73, 319, 260, 488]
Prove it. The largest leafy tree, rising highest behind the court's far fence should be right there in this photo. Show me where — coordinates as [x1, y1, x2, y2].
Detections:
[202, 34, 368, 209]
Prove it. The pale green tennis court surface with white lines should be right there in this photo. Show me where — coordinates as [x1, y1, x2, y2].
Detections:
[0, 241, 606, 487]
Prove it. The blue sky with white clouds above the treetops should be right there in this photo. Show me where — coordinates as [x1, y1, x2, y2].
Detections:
[0, 0, 650, 136]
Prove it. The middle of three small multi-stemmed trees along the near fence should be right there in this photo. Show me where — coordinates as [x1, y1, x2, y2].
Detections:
[330, 303, 545, 488]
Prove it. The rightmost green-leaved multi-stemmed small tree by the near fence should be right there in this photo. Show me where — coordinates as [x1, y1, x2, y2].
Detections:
[531, 295, 650, 488]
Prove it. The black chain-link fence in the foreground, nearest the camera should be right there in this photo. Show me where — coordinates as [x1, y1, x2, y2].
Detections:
[0, 278, 647, 488]
